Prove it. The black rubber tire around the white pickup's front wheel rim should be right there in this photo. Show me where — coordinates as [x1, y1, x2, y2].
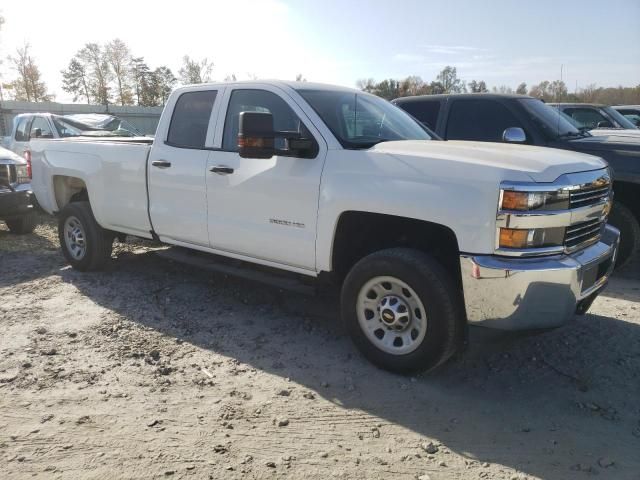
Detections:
[341, 248, 466, 373]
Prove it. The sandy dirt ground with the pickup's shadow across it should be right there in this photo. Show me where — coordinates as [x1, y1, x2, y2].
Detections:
[0, 217, 640, 480]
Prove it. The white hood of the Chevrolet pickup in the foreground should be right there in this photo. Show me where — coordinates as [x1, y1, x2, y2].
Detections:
[372, 140, 607, 183]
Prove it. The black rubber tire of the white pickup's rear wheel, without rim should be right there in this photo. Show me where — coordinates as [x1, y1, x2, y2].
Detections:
[58, 202, 113, 272]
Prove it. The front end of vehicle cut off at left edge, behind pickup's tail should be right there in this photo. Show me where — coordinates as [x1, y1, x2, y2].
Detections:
[0, 147, 36, 233]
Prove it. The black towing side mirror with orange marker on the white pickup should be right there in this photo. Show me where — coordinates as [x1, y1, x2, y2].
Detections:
[238, 112, 275, 159]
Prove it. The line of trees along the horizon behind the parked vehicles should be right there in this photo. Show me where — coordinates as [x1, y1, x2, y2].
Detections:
[0, 16, 640, 106]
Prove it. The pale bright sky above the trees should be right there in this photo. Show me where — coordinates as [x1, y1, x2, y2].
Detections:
[0, 0, 640, 102]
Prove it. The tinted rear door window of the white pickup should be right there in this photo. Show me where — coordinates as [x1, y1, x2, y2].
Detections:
[167, 90, 218, 148]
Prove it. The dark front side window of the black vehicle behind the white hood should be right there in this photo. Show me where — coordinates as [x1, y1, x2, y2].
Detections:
[446, 99, 524, 142]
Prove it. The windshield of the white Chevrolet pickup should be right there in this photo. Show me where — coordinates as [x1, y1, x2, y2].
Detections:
[297, 89, 433, 149]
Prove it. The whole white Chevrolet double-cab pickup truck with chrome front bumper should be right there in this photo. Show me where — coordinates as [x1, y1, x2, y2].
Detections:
[32, 81, 619, 371]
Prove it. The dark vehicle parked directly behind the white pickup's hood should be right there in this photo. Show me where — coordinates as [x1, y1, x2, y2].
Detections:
[393, 94, 640, 265]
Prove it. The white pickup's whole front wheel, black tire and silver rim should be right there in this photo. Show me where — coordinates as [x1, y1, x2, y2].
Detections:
[341, 248, 465, 373]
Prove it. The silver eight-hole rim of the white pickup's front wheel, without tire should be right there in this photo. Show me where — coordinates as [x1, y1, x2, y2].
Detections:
[356, 277, 427, 355]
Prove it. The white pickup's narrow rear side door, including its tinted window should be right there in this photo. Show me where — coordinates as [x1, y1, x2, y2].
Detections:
[149, 88, 221, 247]
